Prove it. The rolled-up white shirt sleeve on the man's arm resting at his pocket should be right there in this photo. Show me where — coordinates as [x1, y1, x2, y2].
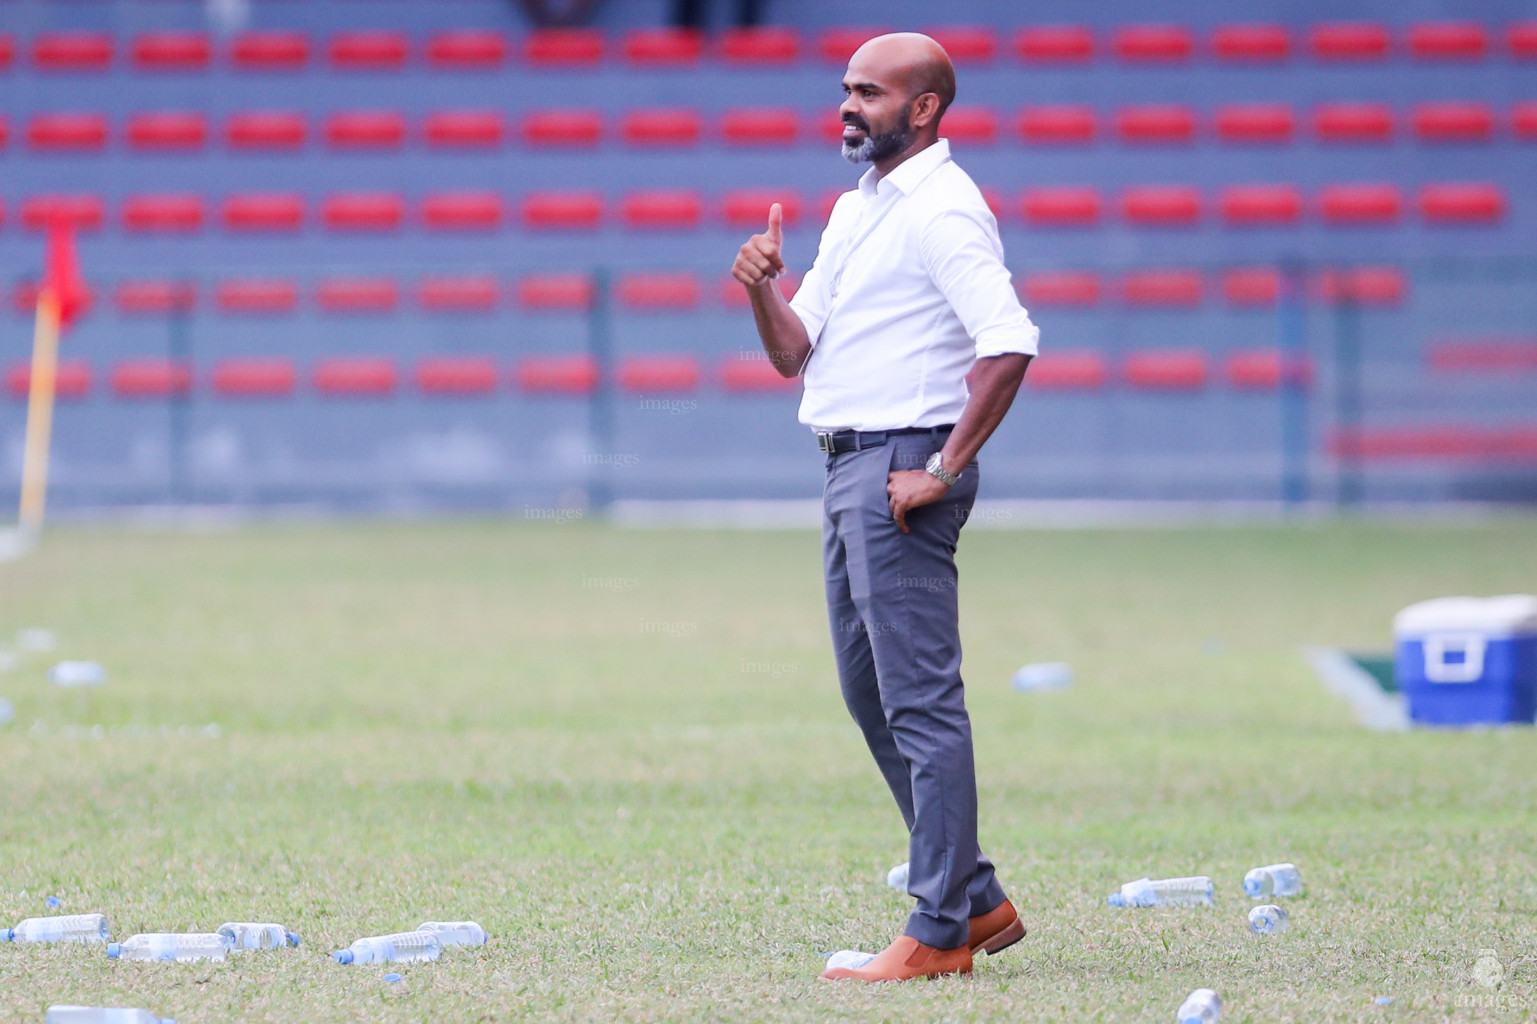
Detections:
[919, 209, 1041, 360]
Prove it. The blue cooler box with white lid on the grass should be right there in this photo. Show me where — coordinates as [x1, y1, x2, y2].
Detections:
[1393, 593, 1537, 726]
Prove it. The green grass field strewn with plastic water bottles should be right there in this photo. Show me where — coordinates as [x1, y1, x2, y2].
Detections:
[0, 520, 1537, 1024]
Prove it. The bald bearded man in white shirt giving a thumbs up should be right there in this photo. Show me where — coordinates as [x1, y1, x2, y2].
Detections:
[732, 32, 1039, 981]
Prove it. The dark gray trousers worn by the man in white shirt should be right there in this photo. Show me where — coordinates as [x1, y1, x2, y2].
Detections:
[822, 432, 1004, 949]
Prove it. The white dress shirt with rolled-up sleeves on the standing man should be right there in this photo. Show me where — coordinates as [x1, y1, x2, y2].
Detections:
[790, 138, 1041, 431]
